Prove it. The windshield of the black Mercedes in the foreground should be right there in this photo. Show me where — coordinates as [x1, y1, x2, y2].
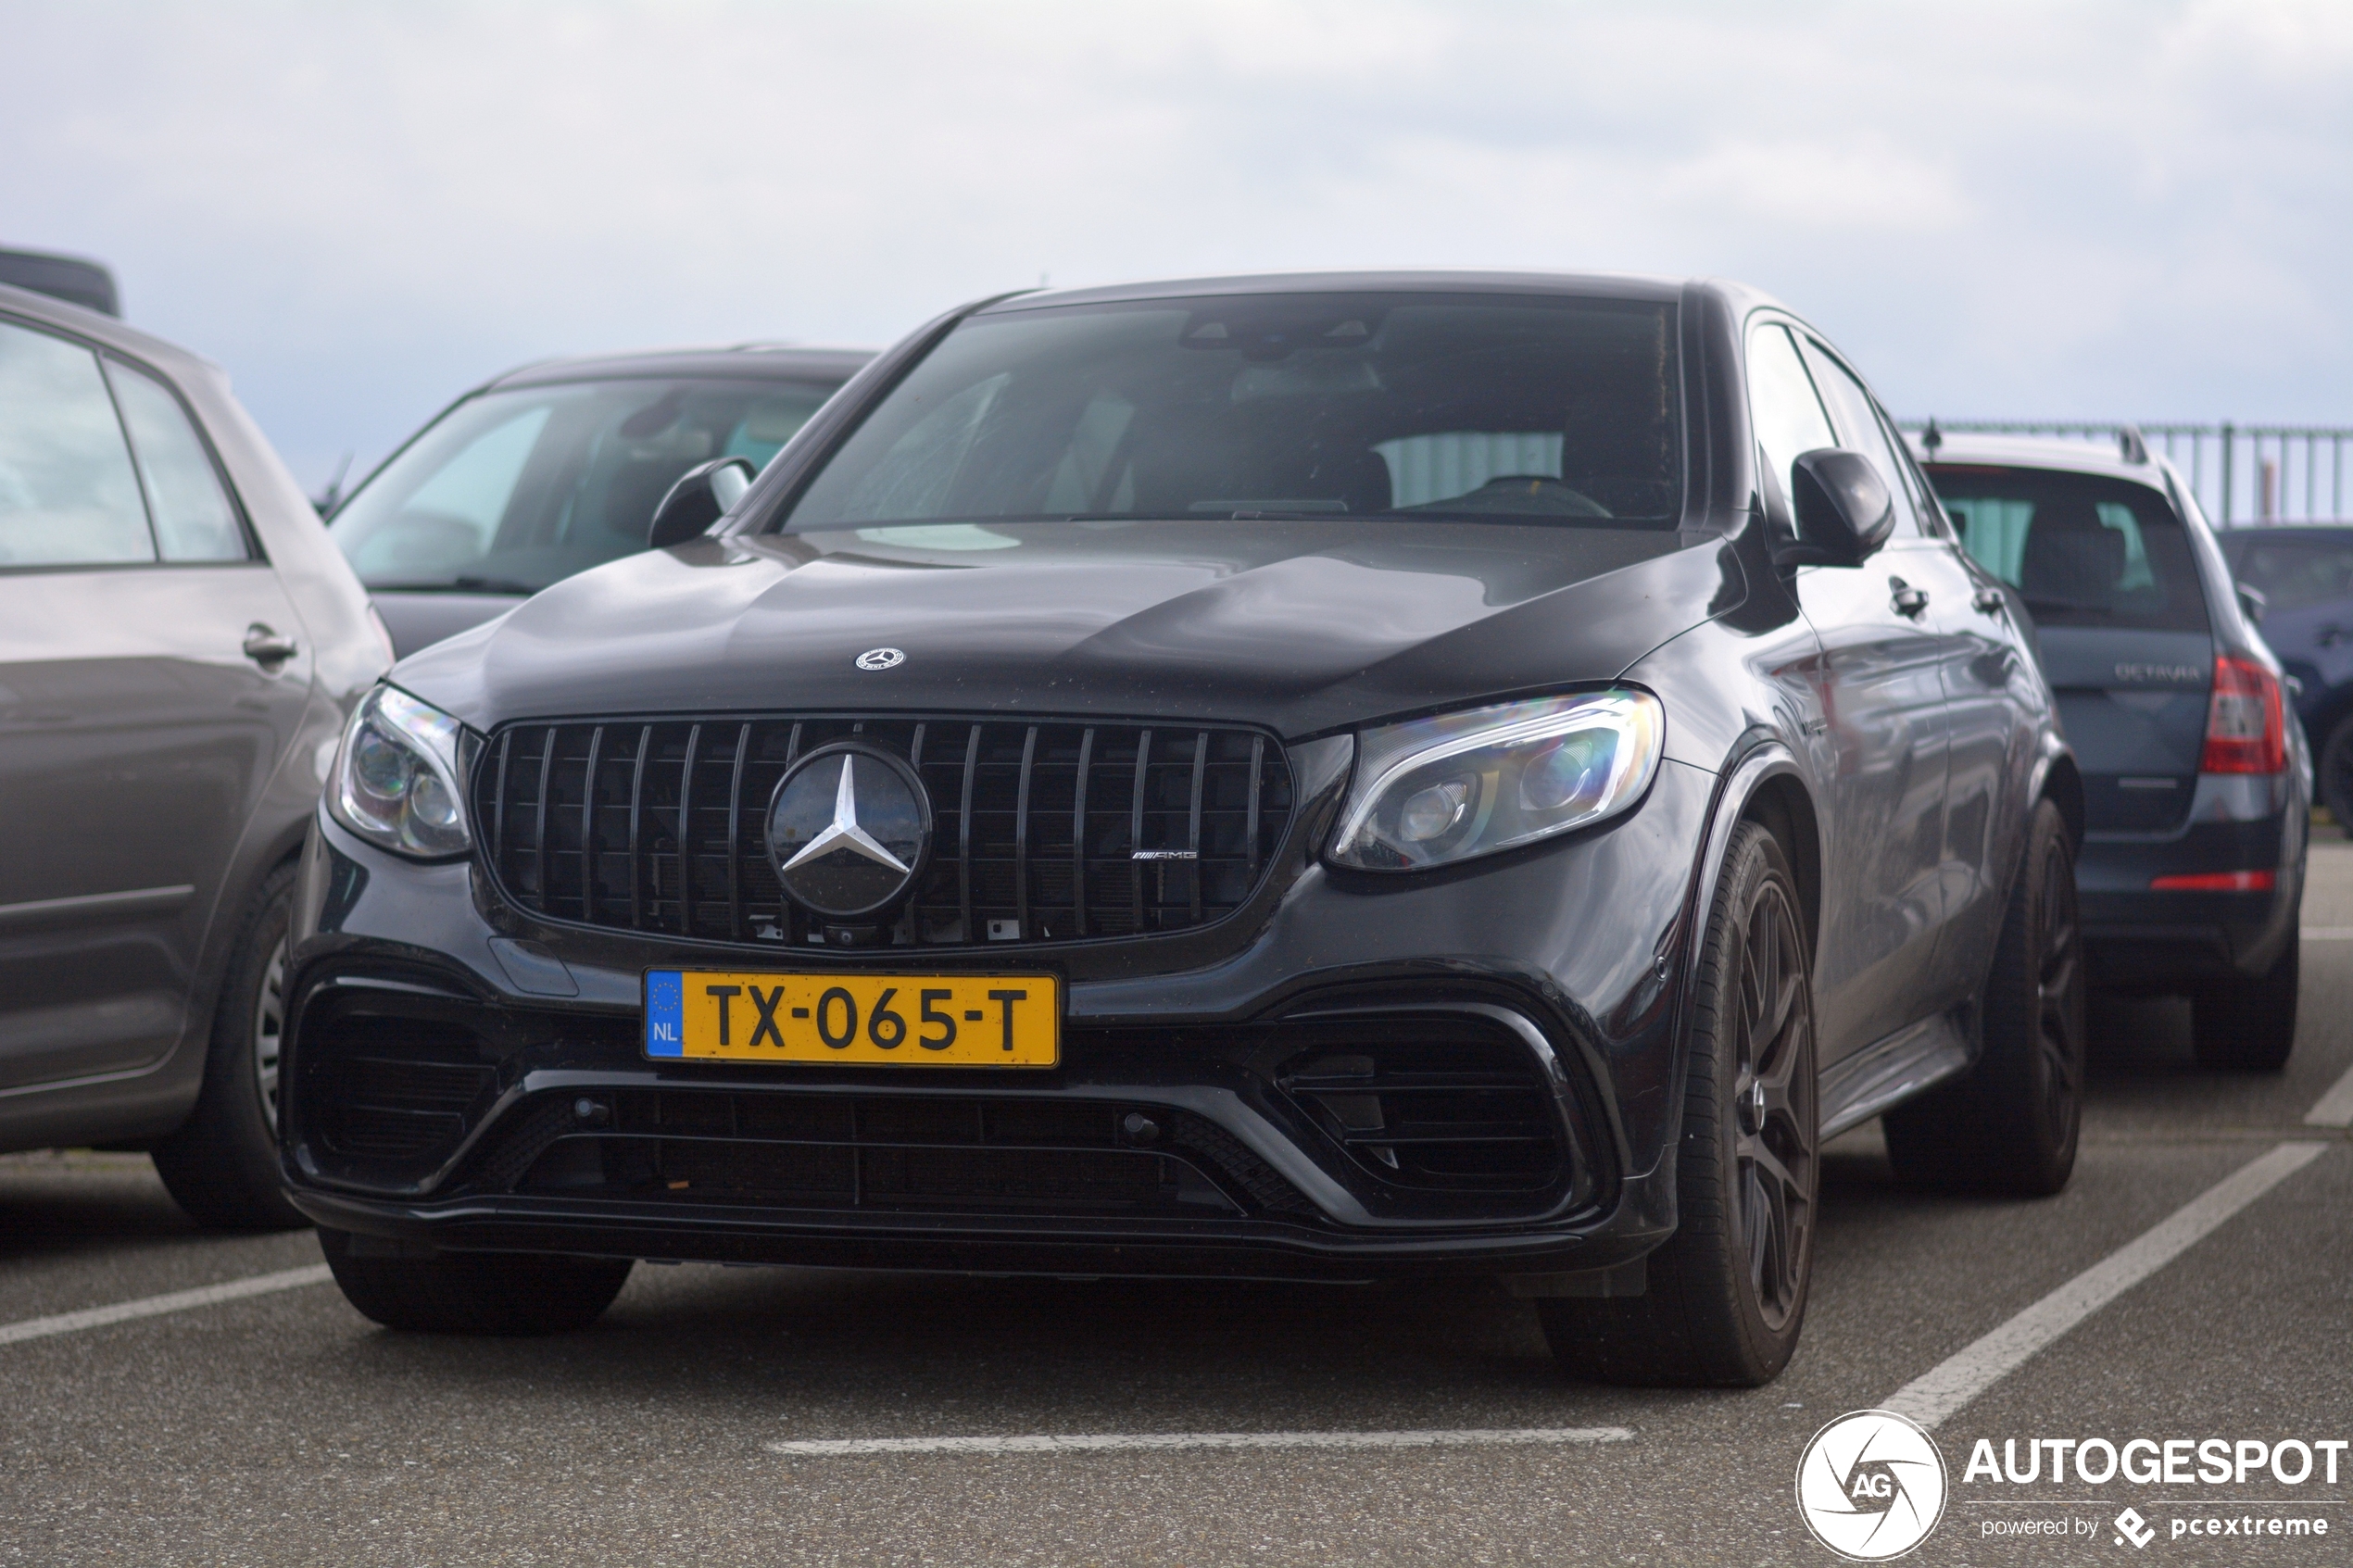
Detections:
[786, 294, 1682, 529]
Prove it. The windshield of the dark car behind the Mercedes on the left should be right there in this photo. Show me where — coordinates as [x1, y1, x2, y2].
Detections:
[327, 381, 833, 593]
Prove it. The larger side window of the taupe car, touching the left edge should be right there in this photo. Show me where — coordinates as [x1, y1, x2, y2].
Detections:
[0, 322, 156, 569]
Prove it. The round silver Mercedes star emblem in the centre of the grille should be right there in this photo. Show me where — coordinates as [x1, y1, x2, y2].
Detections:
[767, 741, 932, 919]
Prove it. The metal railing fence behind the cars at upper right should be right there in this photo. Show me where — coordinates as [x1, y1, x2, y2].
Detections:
[1901, 419, 2353, 529]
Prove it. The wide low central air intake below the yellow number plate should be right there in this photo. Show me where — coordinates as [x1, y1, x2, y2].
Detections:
[483, 1088, 1306, 1218]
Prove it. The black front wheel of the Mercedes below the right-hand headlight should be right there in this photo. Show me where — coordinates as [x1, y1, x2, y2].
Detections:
[1537, 822, 1821, 1387]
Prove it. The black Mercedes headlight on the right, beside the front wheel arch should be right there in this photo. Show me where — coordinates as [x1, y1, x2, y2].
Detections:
[1332, 691, 1666, 872]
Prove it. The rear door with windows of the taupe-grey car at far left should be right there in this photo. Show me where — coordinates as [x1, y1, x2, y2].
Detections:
[0, 320, 310, 1088]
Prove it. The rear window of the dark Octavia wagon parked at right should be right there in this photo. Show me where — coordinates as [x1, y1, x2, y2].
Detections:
[1927, 463, 2208, 633]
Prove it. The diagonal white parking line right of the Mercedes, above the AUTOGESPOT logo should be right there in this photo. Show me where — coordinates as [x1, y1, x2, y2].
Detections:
[1880, 1142, 2341, 1427]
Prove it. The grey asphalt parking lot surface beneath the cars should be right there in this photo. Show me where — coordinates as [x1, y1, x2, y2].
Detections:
[0, 834, 2353, 1563]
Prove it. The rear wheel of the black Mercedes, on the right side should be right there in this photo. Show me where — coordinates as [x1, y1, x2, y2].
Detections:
[1880, 799, 2084, 1197]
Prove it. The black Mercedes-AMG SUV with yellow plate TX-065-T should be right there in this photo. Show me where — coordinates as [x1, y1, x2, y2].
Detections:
[283, 275, 2082, 1382]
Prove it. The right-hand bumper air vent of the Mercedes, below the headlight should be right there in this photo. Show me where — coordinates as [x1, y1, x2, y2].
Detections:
[1277, 1041, 1567, 1192]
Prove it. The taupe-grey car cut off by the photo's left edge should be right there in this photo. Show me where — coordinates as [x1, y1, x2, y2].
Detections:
[0, 287, 391, 1227]
